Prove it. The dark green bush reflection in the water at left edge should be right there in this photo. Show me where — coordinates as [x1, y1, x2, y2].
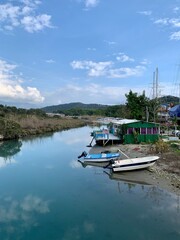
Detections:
[0, 140, 22, 159]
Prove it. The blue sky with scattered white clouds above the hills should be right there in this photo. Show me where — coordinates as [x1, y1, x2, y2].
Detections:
[0, 0, 180, 108]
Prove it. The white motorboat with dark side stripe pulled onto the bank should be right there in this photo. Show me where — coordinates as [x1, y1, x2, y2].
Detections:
[111, 156, 159, 172]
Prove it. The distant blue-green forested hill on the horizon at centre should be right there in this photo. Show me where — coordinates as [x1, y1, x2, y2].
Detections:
[42, 102, 108, 113]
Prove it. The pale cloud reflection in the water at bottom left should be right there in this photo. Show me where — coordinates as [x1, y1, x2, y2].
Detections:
[0, 194, 50, 236]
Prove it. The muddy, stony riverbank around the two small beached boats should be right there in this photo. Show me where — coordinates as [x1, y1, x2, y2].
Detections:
[91, 144, 180, 195]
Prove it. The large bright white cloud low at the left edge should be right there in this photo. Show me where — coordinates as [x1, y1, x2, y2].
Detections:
[0, 60, 44, 104]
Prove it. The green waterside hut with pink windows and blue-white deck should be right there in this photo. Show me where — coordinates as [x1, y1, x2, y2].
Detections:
[90, 119, 160, 146]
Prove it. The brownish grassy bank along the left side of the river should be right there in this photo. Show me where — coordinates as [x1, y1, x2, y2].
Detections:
[0, 114, 86, 140]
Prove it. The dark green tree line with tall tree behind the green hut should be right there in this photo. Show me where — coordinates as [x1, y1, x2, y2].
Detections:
[54, 90, 159, 120]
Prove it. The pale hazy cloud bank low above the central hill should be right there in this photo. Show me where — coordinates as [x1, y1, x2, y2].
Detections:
[46, 83, 147, 104]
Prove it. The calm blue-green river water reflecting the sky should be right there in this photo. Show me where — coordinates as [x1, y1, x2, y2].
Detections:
[0, 127, 180, 240]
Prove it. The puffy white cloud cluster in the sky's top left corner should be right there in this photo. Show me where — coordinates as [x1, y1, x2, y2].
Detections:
[0, 0, 52, 33]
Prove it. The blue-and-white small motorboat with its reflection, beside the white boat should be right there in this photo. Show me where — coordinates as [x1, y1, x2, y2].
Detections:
[78, 151, 120, 167]
